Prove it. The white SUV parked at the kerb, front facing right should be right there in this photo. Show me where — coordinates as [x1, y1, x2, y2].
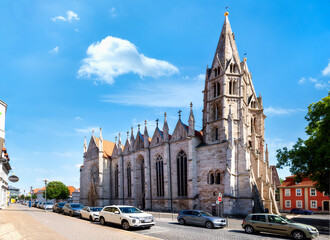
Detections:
[100, 205, 155, 230]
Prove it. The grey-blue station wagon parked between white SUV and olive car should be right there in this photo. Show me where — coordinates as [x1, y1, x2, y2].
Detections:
[177, 210, 227, 228]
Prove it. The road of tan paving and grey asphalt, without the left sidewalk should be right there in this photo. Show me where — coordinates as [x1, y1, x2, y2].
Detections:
[0, 206, 330, 240]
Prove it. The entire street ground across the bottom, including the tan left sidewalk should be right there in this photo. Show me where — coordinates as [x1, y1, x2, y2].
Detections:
[0, 205, 329, 240]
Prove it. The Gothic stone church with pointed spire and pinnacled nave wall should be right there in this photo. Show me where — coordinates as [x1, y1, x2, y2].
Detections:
[80, 13, 278, 215]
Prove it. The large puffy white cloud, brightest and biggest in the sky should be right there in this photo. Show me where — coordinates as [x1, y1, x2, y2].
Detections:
[78, 36, 179, 84]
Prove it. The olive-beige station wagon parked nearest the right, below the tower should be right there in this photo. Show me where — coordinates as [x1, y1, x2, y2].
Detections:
[242, 213, 319, 239]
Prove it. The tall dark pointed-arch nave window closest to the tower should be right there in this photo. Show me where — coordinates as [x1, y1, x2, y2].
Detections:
[176, 150, 187, 197]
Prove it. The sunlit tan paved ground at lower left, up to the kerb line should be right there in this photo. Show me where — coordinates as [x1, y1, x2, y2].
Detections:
[0, 205, 157, 240]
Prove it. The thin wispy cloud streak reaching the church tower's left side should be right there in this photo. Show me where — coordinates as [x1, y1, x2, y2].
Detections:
[102, 74, 205, 108]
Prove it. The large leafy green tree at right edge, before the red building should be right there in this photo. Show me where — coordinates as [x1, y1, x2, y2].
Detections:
[276, 92, 330, 194]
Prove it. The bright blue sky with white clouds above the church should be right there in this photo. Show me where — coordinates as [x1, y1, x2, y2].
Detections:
[0, 0, 330, 193]
